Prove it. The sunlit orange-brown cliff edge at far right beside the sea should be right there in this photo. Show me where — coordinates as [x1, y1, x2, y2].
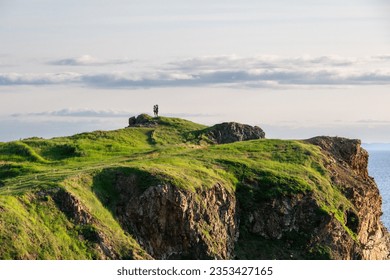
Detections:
[307, 137, 390, 260]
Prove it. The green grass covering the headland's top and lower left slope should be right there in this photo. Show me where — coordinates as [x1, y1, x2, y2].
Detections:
[0, 117, 350, 259]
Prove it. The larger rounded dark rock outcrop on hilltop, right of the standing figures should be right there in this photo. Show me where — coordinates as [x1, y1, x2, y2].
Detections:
[205, 122, 265, 144]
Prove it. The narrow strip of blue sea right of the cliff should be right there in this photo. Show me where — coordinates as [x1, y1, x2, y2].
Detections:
[365, 147, 390, 230]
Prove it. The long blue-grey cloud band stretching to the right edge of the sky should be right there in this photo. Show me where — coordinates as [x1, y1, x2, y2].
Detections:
[74, 68, 390, 88]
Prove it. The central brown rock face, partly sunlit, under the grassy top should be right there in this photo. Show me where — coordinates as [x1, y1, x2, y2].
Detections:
[116, 176, 238, 259]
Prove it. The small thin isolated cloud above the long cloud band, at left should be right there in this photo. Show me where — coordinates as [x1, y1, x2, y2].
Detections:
[49, 55, 134, 66]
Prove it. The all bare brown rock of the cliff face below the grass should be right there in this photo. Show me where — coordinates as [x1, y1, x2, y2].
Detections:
[106, 137, 390, 260]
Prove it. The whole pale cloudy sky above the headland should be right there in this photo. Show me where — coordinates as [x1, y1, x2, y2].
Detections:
[0, 0, 390, 143]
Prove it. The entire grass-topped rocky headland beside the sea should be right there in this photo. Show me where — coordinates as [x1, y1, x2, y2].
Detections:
[0, 115, 390, 260]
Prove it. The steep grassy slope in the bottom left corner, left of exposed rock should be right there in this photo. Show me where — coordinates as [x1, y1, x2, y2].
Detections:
[0, 194, 96, 259]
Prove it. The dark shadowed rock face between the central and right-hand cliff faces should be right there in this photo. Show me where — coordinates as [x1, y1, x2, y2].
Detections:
[238, 193, 342, 259]
